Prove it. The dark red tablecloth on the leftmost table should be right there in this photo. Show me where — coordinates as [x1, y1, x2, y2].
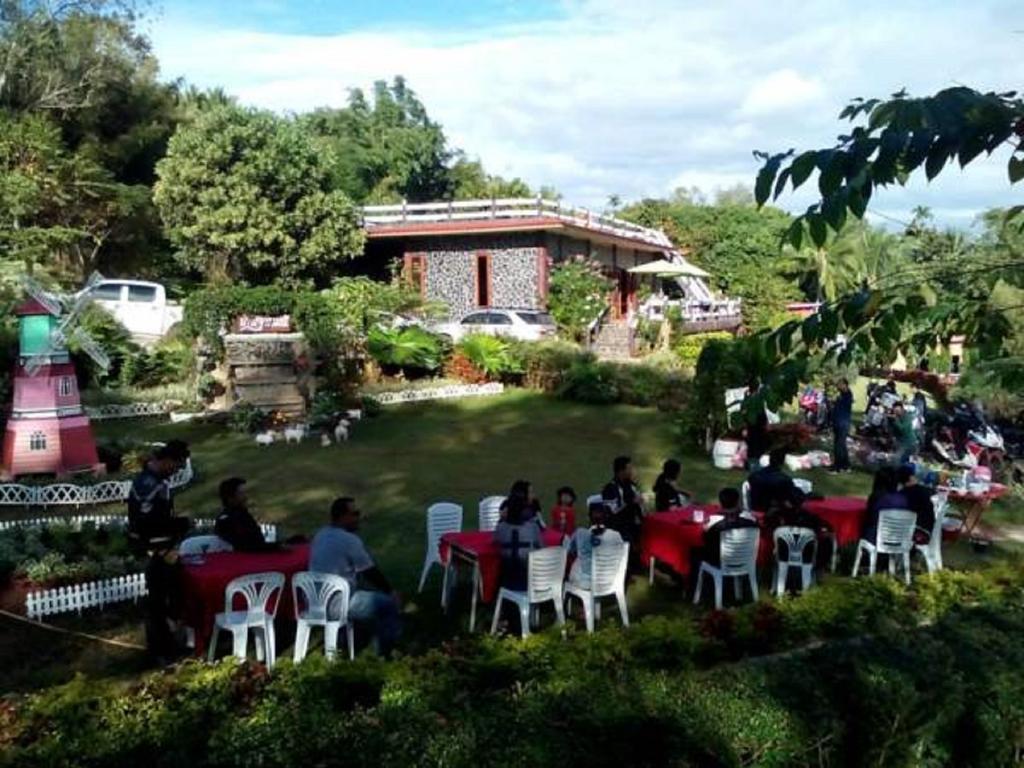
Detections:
[181, 544, 309, 654]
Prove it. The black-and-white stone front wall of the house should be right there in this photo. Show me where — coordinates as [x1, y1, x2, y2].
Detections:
[406, 232, 545, 319]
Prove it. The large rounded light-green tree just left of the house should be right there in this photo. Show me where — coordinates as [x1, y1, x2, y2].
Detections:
[154, 105, 365, 285]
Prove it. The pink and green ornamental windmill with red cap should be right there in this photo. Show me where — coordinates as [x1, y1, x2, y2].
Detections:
[0, 274, 110, 478]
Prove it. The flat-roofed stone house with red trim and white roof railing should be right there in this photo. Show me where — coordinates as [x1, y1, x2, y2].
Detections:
[360, 199, 740, 356]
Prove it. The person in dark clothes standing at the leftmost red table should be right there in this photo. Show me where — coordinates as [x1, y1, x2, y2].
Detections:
[128, 440, 191, 666]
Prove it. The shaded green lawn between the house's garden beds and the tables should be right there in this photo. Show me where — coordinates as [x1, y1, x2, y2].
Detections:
[0, 390, 1021, 692]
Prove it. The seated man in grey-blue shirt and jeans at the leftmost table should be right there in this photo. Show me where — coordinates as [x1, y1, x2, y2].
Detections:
[309, 497, 401, 658]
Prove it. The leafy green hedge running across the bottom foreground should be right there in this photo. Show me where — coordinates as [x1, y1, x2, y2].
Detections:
[8, 567, 1024, 768]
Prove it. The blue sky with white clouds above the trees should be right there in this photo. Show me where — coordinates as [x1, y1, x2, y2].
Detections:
[145, 0, 1024, 227]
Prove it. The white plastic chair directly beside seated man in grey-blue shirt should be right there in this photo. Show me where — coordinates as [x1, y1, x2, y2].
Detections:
[292, 570, 355, 664]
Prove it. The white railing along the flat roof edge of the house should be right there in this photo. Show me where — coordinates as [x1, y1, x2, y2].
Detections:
[362, 198, 674, 249]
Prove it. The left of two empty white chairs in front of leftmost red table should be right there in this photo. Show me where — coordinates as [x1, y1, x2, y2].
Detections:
[207, 571, 285, 669]
